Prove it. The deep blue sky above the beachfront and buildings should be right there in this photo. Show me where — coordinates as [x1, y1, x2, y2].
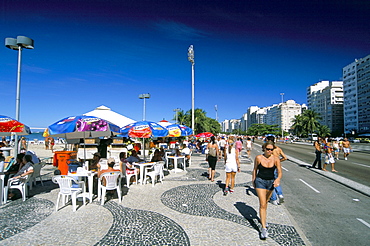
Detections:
[0, 0, 370, 127]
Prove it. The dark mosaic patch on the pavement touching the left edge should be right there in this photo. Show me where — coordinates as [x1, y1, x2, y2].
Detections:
[0, 197, 54, 240]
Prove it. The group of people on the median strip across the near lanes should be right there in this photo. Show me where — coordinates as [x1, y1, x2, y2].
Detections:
[311, 137, 352, 172]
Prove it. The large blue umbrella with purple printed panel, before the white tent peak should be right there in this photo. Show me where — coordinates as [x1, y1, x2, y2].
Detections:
[47, 116, 120, 139]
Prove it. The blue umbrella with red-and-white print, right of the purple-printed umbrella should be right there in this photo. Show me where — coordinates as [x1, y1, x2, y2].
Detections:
[120, 121, 168, 138]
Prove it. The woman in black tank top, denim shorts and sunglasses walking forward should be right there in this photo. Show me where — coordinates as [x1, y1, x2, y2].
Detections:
[252, 141, 282, 239]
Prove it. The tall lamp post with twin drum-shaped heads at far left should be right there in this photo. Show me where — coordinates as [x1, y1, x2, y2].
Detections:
[5, 36, 34, 156]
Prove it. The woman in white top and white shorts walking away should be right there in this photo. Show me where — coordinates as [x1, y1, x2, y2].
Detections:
[224, 137, 240, 196]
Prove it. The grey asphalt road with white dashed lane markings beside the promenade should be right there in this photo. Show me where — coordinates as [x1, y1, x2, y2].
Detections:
[253, 142, 370, 245]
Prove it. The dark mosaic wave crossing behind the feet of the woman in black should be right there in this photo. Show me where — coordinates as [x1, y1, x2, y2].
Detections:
[161, 184, 304, 245]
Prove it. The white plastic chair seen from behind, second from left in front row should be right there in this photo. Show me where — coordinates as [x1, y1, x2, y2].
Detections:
[98, 172, 122, 205]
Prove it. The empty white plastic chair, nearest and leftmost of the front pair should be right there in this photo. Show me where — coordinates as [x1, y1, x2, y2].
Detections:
[52, 175, 86, 212]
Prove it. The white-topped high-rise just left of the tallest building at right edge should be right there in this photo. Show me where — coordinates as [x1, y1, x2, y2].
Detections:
[307, 81, 343, 135]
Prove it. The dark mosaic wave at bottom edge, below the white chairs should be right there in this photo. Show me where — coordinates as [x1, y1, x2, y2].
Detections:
[96, 201, 190, 246]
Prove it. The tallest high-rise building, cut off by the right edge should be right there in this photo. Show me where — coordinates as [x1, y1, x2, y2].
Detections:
[343, 55, 370, 135]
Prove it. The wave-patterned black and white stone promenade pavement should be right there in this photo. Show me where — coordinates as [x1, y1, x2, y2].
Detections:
[0, 149, 309, 245]
